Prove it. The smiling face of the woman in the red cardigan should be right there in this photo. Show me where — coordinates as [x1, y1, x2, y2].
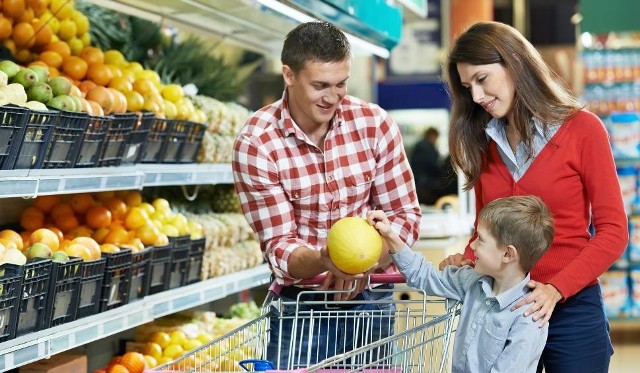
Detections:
[457, 62, 516, 121]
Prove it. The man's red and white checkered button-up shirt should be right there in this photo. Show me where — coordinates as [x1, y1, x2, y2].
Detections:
[232, 92, 421, 286]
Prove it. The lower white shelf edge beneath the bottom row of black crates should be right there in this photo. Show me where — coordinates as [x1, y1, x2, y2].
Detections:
[0, 264, 271, 372]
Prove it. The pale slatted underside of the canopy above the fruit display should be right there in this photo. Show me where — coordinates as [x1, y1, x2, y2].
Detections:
[86, 0, 396, 56]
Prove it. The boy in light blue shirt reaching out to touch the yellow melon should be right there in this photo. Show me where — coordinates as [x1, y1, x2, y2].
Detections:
[367, 196, 554, 373]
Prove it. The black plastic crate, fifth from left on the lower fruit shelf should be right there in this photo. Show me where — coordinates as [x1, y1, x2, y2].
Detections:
[100, 249, 133, 312]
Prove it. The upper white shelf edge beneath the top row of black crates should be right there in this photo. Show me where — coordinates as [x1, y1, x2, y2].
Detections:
[0, 163, 233, 198]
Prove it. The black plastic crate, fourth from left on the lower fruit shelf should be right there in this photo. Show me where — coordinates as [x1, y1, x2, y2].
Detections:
[76, 253, 107, 319]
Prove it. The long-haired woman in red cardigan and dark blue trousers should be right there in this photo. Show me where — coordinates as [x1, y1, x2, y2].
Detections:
[441, 22, 628, 373]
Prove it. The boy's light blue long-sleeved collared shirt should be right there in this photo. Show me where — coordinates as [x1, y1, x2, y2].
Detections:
[391, 247, 548, 373]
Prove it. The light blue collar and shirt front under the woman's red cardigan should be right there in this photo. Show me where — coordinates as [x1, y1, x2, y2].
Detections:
[485, 118, 560, 181]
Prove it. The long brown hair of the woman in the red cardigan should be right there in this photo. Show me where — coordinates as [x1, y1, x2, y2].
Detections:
[445, 22, 581, 190]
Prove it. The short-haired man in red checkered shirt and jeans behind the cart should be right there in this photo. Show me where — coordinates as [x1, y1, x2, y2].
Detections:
[232, 22, 421, 369]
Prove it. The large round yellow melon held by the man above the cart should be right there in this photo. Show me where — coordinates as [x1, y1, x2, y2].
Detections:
[327, 217, 382, 274]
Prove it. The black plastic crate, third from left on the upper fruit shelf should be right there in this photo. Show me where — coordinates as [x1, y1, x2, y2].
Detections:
[42, 110, 89, 168]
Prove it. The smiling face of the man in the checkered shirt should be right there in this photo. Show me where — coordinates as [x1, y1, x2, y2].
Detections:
[282, 59, 351, 131]
